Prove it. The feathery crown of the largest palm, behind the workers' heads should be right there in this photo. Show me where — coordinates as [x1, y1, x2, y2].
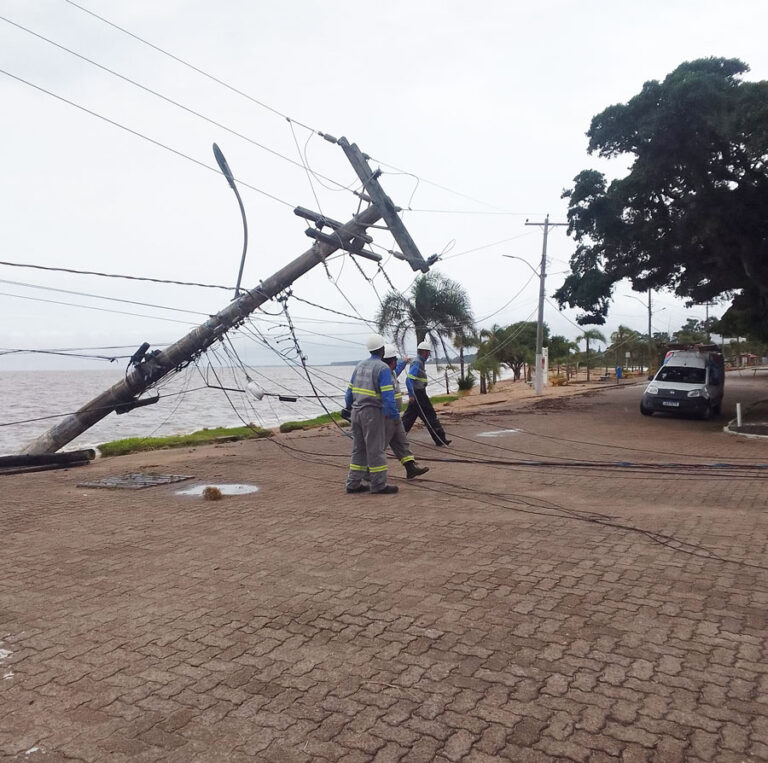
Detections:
[376, 271, 474, 362]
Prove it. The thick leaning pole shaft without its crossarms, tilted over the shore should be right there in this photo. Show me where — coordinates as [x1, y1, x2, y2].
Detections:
[22, 205, 382, 454]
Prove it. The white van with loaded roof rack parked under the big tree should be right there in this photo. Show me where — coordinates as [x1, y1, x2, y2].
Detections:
[640, 347, 725, 419]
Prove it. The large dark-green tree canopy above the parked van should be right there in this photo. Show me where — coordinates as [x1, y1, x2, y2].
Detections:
[555, 58, 768, 336]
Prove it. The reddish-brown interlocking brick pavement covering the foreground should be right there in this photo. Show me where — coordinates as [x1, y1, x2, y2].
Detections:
[0, 380, 768, 762]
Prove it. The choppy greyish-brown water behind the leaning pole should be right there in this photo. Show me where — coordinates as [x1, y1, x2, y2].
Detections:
[0, 366, 455, 455]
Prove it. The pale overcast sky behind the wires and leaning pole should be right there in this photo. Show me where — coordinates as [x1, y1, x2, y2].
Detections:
[0, 0, 768, 370]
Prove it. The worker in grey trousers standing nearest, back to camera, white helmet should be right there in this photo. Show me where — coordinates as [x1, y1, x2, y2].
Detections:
[344, 334, 400, 494]
